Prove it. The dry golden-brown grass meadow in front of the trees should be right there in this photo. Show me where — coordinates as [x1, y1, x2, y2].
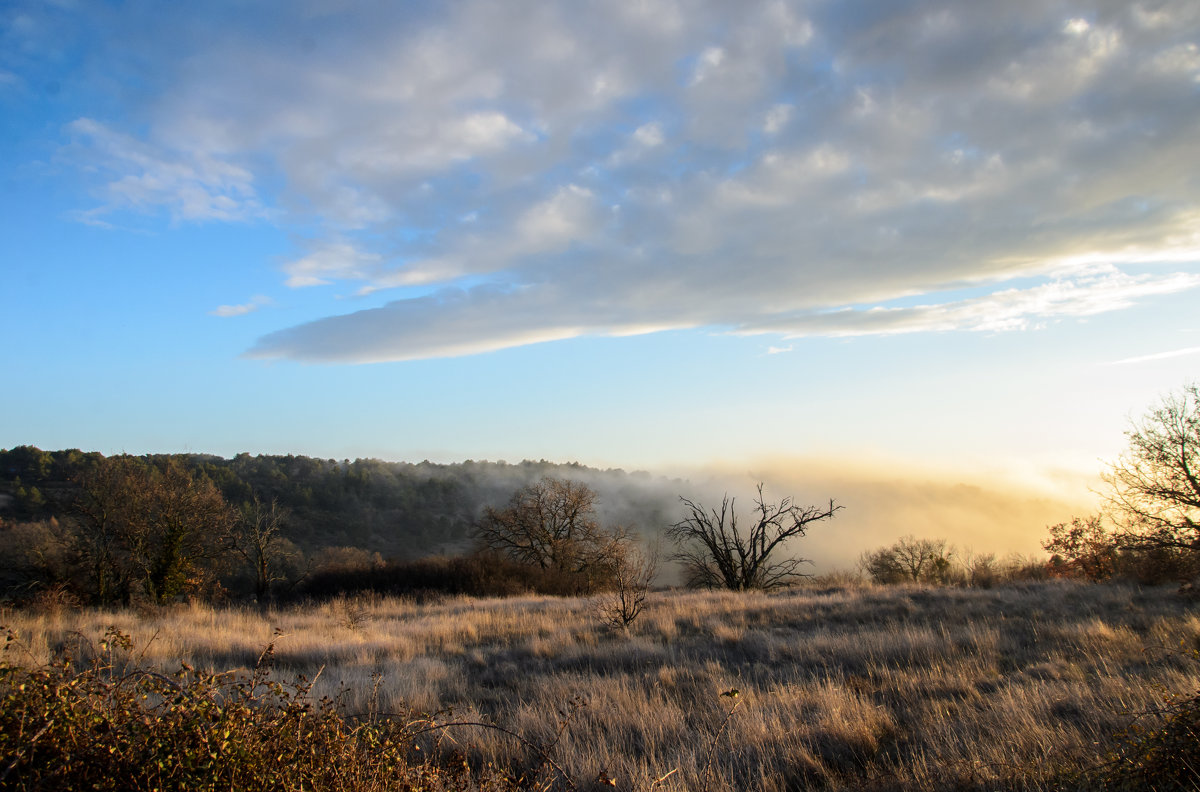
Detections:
[0, 581, 1200, 792]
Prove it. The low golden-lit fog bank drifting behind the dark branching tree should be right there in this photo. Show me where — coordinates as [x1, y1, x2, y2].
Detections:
[514, 458, 1100, 583]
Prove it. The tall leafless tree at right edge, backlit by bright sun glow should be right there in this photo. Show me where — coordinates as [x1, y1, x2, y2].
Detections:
[1103, 384, 1200, 554]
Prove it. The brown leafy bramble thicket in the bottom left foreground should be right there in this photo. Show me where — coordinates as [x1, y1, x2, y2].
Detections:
[0, 630, 520, 792]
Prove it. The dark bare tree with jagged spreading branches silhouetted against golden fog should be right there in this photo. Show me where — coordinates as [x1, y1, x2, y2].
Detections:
[667, 484, 842, 592]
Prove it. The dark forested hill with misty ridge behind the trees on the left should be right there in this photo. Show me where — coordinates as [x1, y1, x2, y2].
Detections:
[0, 445, 683, 559]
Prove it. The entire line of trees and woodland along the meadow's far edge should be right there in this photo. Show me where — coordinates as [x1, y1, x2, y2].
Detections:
[0, 385, 1200, 602]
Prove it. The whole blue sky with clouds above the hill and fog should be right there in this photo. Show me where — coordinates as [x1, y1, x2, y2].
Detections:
[0, 0, 1200, 554]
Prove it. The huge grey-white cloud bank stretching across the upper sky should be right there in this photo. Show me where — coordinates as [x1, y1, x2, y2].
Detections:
[35, 0, 1200, 361]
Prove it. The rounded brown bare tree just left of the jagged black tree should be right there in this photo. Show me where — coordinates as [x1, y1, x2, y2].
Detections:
[475, 478, 630, 578]
